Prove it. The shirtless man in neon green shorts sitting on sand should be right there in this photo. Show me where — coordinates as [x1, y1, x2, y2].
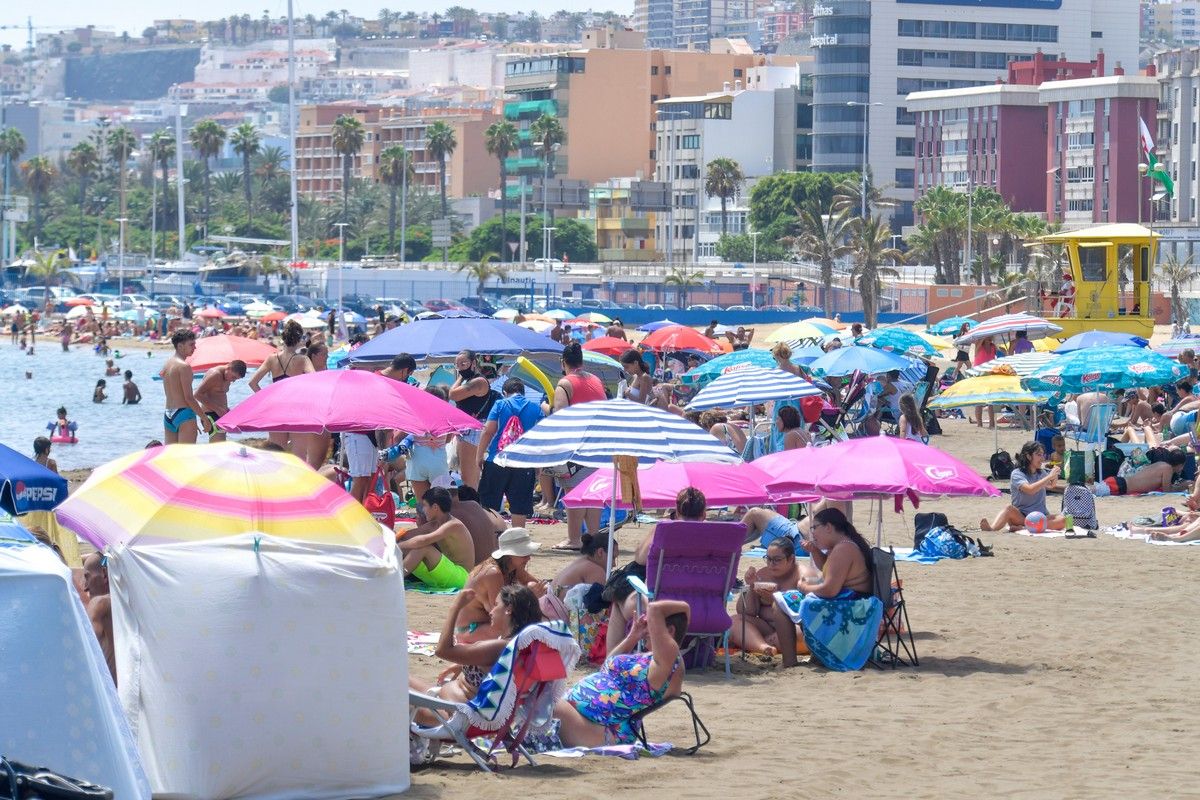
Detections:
[396, 488, 475, 589]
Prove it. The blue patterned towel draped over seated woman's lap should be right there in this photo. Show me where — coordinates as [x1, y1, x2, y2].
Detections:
[775, 589, 883, 672]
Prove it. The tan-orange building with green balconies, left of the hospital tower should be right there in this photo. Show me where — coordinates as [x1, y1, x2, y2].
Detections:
[504, 48, 798, 184]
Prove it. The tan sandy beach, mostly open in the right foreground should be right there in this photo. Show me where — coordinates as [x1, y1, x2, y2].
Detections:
[408, 412, 1200, 800]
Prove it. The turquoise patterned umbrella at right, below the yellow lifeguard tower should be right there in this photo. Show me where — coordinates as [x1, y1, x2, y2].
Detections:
[1025, 347, 1188, 393]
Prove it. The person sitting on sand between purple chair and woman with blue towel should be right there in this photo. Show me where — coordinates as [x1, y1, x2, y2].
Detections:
[730, 536, 800, 667]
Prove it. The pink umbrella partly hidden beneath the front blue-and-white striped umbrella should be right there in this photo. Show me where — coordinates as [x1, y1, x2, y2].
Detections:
[563, 462, 796, 509]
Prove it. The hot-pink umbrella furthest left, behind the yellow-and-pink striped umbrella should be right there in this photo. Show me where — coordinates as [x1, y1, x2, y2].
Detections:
[220, 369, 482, 435]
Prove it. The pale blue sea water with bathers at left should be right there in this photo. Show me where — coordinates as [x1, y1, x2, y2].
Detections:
[0, 340, 251, 469]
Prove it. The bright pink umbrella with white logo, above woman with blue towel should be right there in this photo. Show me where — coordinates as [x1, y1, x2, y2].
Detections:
[754, 437, 1000, 540]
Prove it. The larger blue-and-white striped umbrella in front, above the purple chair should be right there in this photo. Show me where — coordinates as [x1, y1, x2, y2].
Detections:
[496, 399, 740, 468]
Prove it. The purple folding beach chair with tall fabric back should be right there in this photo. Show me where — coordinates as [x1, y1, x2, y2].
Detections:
[646, 521, 746, 675]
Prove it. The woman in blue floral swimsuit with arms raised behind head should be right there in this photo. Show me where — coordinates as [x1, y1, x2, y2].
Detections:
[554, 600, 689, 747]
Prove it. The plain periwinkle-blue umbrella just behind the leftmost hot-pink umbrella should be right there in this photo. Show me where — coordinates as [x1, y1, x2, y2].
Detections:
[350, 317, 563, 365]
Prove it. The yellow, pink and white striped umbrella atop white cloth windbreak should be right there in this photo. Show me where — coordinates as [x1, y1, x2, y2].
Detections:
[58, 441, 384, 552]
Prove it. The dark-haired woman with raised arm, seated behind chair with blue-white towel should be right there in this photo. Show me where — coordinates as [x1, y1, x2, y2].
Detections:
[408, 585, 541, 724]
